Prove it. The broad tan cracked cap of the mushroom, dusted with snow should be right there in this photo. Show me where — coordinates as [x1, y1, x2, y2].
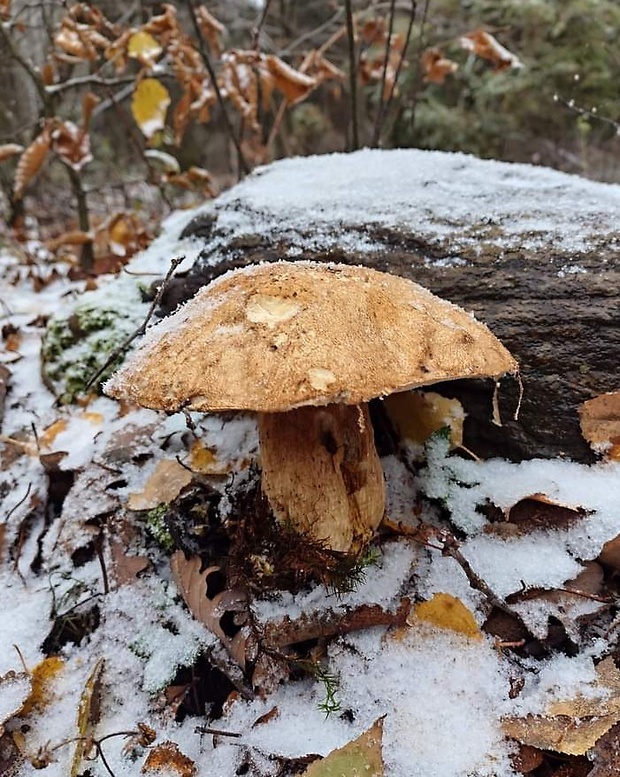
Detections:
[104, 261, 518, 413]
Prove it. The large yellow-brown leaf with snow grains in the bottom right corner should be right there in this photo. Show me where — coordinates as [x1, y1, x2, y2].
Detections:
[502, 656, 620, 755]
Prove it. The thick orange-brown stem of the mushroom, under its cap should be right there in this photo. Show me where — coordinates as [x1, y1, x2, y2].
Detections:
[258, 404, 385, 553]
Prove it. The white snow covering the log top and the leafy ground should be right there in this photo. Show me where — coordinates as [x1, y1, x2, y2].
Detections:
[0, 151, 620, 777]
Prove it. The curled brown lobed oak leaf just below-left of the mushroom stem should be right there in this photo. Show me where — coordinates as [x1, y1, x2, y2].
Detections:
[170, 551, 248, 669]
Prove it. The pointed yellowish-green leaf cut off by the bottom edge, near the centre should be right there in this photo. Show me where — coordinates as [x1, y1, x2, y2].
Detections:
[303, 718, 385, 777]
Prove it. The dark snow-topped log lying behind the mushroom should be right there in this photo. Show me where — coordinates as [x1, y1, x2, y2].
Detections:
[162, 150, 620, 462]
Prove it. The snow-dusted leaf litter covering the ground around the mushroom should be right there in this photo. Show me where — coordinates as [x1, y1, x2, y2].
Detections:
[0, 149, 620, 777]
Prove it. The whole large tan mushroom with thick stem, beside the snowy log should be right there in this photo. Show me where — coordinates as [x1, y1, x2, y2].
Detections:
[105, 261, 517, 553]
